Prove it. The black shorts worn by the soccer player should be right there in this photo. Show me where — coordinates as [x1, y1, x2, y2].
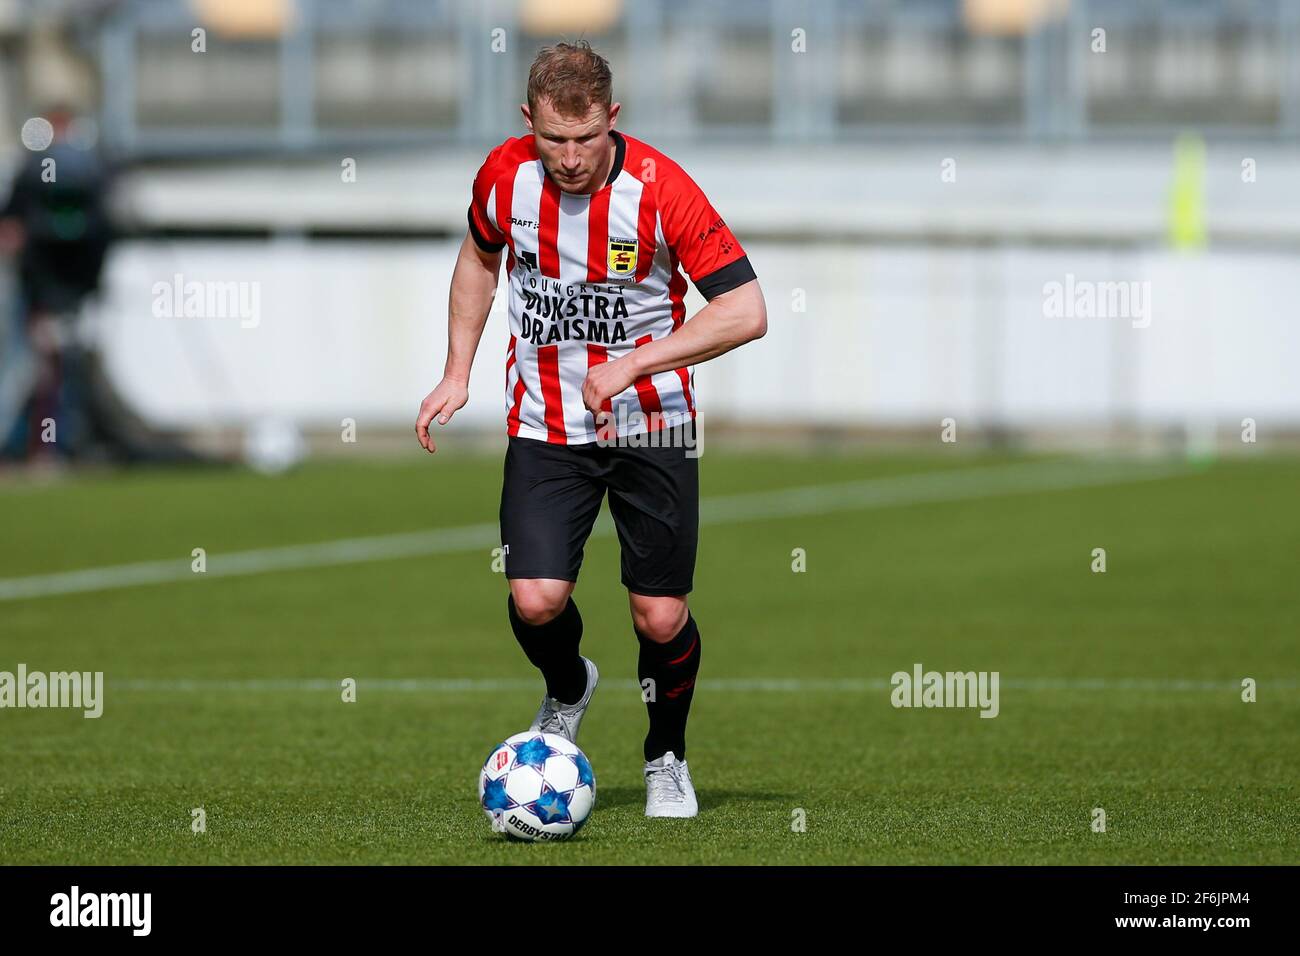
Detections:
[501, 423, 699, 596]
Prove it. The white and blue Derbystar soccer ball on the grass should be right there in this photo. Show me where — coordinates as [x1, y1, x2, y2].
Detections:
[478, 730, 595, 840]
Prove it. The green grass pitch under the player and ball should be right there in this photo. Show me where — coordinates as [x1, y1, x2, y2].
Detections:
[0, 450, 1300, 864]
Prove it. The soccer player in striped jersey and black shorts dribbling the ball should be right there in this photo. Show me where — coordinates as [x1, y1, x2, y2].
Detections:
[416, 42, 767, 817]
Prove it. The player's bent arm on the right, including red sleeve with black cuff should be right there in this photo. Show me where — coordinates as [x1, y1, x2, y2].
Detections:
[582, 166, 767, 412]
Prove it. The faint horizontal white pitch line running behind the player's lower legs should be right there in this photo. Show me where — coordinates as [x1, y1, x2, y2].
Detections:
[108, 678, 1300, 693]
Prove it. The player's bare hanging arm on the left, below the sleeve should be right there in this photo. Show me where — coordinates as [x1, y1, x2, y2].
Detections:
[415, 233, 502, 454]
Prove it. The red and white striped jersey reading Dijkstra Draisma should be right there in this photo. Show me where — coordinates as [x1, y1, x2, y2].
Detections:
[469, 130, 754, 445]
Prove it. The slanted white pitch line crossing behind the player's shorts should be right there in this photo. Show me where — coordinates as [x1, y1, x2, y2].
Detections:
[0, 460, 1190, 601]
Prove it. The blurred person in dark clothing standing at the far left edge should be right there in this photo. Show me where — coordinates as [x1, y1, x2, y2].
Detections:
[0, 105, 113, 460]
